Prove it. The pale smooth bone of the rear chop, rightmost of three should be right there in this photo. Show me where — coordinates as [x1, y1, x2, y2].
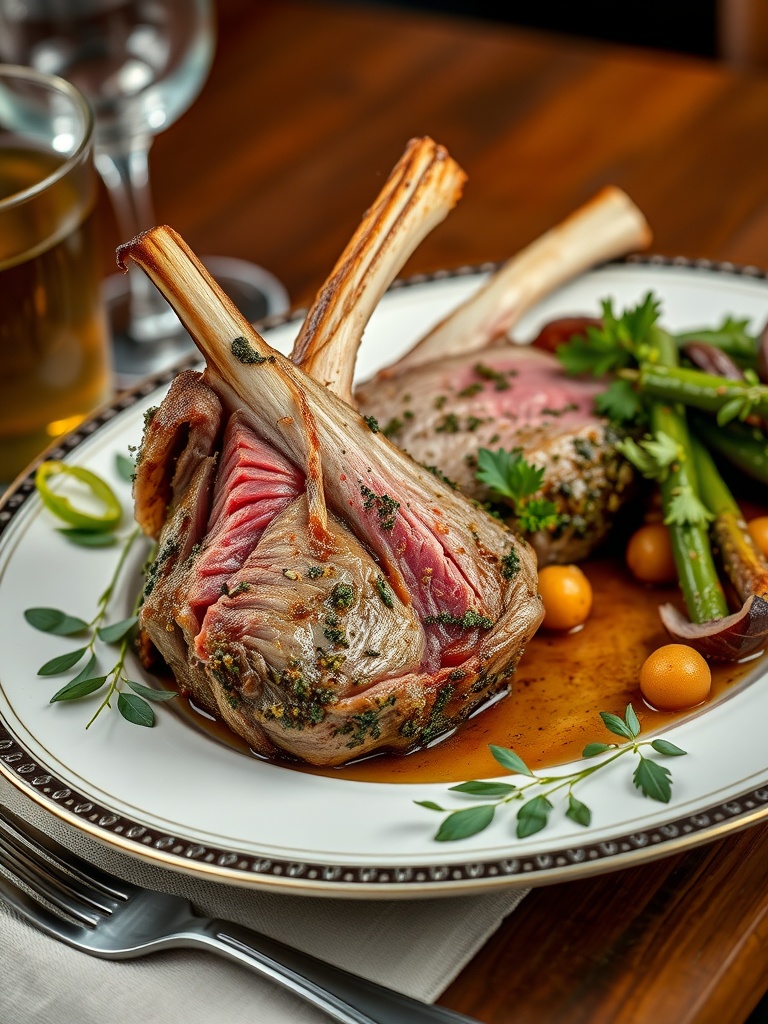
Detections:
[381, 185, 651, 376]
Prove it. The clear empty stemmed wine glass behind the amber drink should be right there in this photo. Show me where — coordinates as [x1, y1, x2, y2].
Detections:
[0, 0, 289, 387]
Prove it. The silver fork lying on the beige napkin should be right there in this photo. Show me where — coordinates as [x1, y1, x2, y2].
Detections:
[0, 807, 478, 1024]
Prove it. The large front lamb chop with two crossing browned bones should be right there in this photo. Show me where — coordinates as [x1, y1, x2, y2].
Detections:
[126, 140, 543, 765]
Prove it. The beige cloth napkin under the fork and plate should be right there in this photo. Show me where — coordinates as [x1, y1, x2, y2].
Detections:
[0, 779, 525, 1024]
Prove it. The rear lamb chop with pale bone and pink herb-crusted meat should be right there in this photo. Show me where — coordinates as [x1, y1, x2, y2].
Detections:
[301, 187, 650, 564]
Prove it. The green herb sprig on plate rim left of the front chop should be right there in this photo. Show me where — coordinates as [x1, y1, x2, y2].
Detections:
[24, 456, 177, 729]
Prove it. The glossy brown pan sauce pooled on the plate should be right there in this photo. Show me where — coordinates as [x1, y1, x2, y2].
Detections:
[172, 557, 756, 783]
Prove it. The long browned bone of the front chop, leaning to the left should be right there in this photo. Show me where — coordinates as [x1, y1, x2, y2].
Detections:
[119, 226, 530, 613]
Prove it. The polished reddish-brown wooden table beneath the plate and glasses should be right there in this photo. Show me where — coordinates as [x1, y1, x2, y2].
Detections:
[97, 0, 768, 1024]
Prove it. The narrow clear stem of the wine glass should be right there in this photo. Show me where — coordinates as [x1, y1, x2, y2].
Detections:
[94, 135, 181, 342]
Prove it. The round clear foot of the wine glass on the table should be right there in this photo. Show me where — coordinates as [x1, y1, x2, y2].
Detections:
[103, 256, 290, 390]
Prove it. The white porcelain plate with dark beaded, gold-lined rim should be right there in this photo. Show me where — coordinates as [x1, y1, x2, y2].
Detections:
[0, 260, 768, 898]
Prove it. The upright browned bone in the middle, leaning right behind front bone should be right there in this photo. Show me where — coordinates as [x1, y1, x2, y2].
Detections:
[291, 137, 466, 406]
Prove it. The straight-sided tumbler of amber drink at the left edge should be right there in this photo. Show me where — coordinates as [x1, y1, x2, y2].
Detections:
[0, 65, 112, 489]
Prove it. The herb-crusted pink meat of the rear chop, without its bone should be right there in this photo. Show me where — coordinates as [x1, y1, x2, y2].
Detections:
[356, 344, 635, 565]
